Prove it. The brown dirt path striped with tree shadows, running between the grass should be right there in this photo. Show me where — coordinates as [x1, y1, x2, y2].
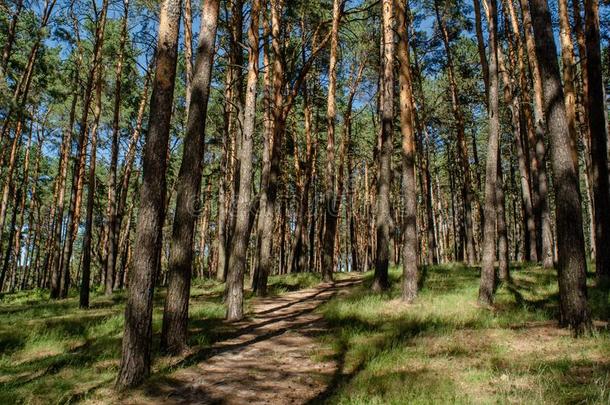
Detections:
[131, 275, 362, 405]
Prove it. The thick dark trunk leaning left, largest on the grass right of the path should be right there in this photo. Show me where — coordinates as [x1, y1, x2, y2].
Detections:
[530, 0, 591, 335]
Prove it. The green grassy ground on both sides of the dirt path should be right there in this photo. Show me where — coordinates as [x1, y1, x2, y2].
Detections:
[0, 265, 610, 404]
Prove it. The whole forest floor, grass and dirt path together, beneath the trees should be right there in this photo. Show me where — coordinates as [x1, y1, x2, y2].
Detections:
[0, 265, 610, 405]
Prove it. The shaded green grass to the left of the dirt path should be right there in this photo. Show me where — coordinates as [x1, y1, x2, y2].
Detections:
[0, 274, 320, 404]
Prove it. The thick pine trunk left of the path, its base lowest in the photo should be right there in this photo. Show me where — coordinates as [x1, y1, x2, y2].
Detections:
[116, 0, 181, 389]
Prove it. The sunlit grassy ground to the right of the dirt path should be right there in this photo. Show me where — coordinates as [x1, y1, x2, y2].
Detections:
[317, 265, 610, 404]
